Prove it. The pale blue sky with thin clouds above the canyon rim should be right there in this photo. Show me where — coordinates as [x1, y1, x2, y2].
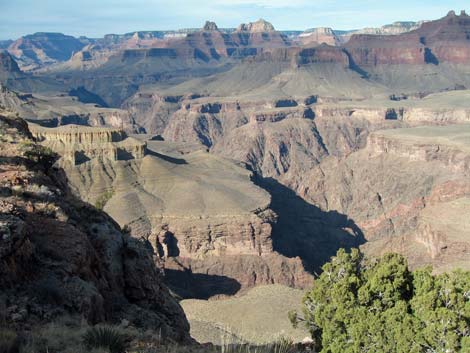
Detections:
[0, 0, 470, 39]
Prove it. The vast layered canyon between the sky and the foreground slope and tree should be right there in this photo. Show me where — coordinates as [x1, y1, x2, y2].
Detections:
[0, 11, 470, 346]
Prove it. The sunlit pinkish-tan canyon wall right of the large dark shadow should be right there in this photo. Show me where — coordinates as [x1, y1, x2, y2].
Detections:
[291, 125, 470, 271]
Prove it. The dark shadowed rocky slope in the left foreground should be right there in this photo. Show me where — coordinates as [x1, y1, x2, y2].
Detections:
[0, 114, 190, 342]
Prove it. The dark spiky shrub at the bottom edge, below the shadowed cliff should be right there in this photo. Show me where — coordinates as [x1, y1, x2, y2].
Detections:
[83, 326, 128, 353]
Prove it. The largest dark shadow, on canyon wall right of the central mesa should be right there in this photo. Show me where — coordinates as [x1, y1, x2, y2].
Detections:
[254, 176, 365, 273]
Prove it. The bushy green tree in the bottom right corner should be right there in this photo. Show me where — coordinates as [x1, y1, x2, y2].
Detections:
[290, 250, 470, 353]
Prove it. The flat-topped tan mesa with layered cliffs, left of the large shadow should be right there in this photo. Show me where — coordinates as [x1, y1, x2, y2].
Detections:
[33, 126, 311, 297]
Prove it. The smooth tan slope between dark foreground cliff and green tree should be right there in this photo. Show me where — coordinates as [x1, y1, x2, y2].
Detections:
[181, 285, 308, 345]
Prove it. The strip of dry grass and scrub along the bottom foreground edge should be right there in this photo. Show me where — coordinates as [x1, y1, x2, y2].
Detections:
[4, 317, 312, 353]
